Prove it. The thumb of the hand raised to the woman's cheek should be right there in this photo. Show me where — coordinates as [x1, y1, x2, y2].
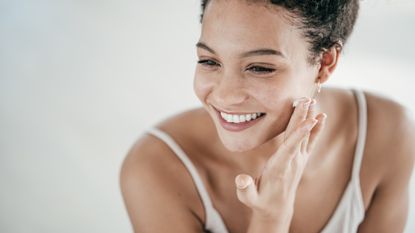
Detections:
[235, 174, 258, 207]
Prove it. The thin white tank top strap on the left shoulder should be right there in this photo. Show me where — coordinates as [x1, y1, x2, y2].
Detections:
[146, 127, 226, 232]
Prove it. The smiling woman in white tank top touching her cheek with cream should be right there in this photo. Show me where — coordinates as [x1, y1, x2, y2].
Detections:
[120, 0, 415, 233]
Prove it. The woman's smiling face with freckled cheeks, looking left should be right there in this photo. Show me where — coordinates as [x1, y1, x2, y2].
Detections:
[194, 0, 319, 152]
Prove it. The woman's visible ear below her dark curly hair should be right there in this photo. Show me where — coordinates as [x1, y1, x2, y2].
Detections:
[317, 45, 342, 83]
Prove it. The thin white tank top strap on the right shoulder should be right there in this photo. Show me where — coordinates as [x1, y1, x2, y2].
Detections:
[352, 88, 367, 179]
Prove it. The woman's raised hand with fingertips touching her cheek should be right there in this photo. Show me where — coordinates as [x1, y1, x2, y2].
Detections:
[235, 98, 326, 221]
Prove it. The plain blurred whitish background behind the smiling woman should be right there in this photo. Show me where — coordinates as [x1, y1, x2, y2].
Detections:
[0, 0, 415, 233]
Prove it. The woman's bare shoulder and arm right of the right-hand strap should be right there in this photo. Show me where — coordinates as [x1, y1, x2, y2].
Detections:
[359, 91, 415, 233]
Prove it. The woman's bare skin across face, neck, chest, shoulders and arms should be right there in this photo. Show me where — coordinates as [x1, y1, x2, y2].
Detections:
[120, 0, 415, 233]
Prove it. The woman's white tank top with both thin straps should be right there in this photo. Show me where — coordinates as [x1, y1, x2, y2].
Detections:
[147, 89, 367, 233]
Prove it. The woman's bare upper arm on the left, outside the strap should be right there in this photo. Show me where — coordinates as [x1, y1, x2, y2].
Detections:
[120, 136, 202, 233]
